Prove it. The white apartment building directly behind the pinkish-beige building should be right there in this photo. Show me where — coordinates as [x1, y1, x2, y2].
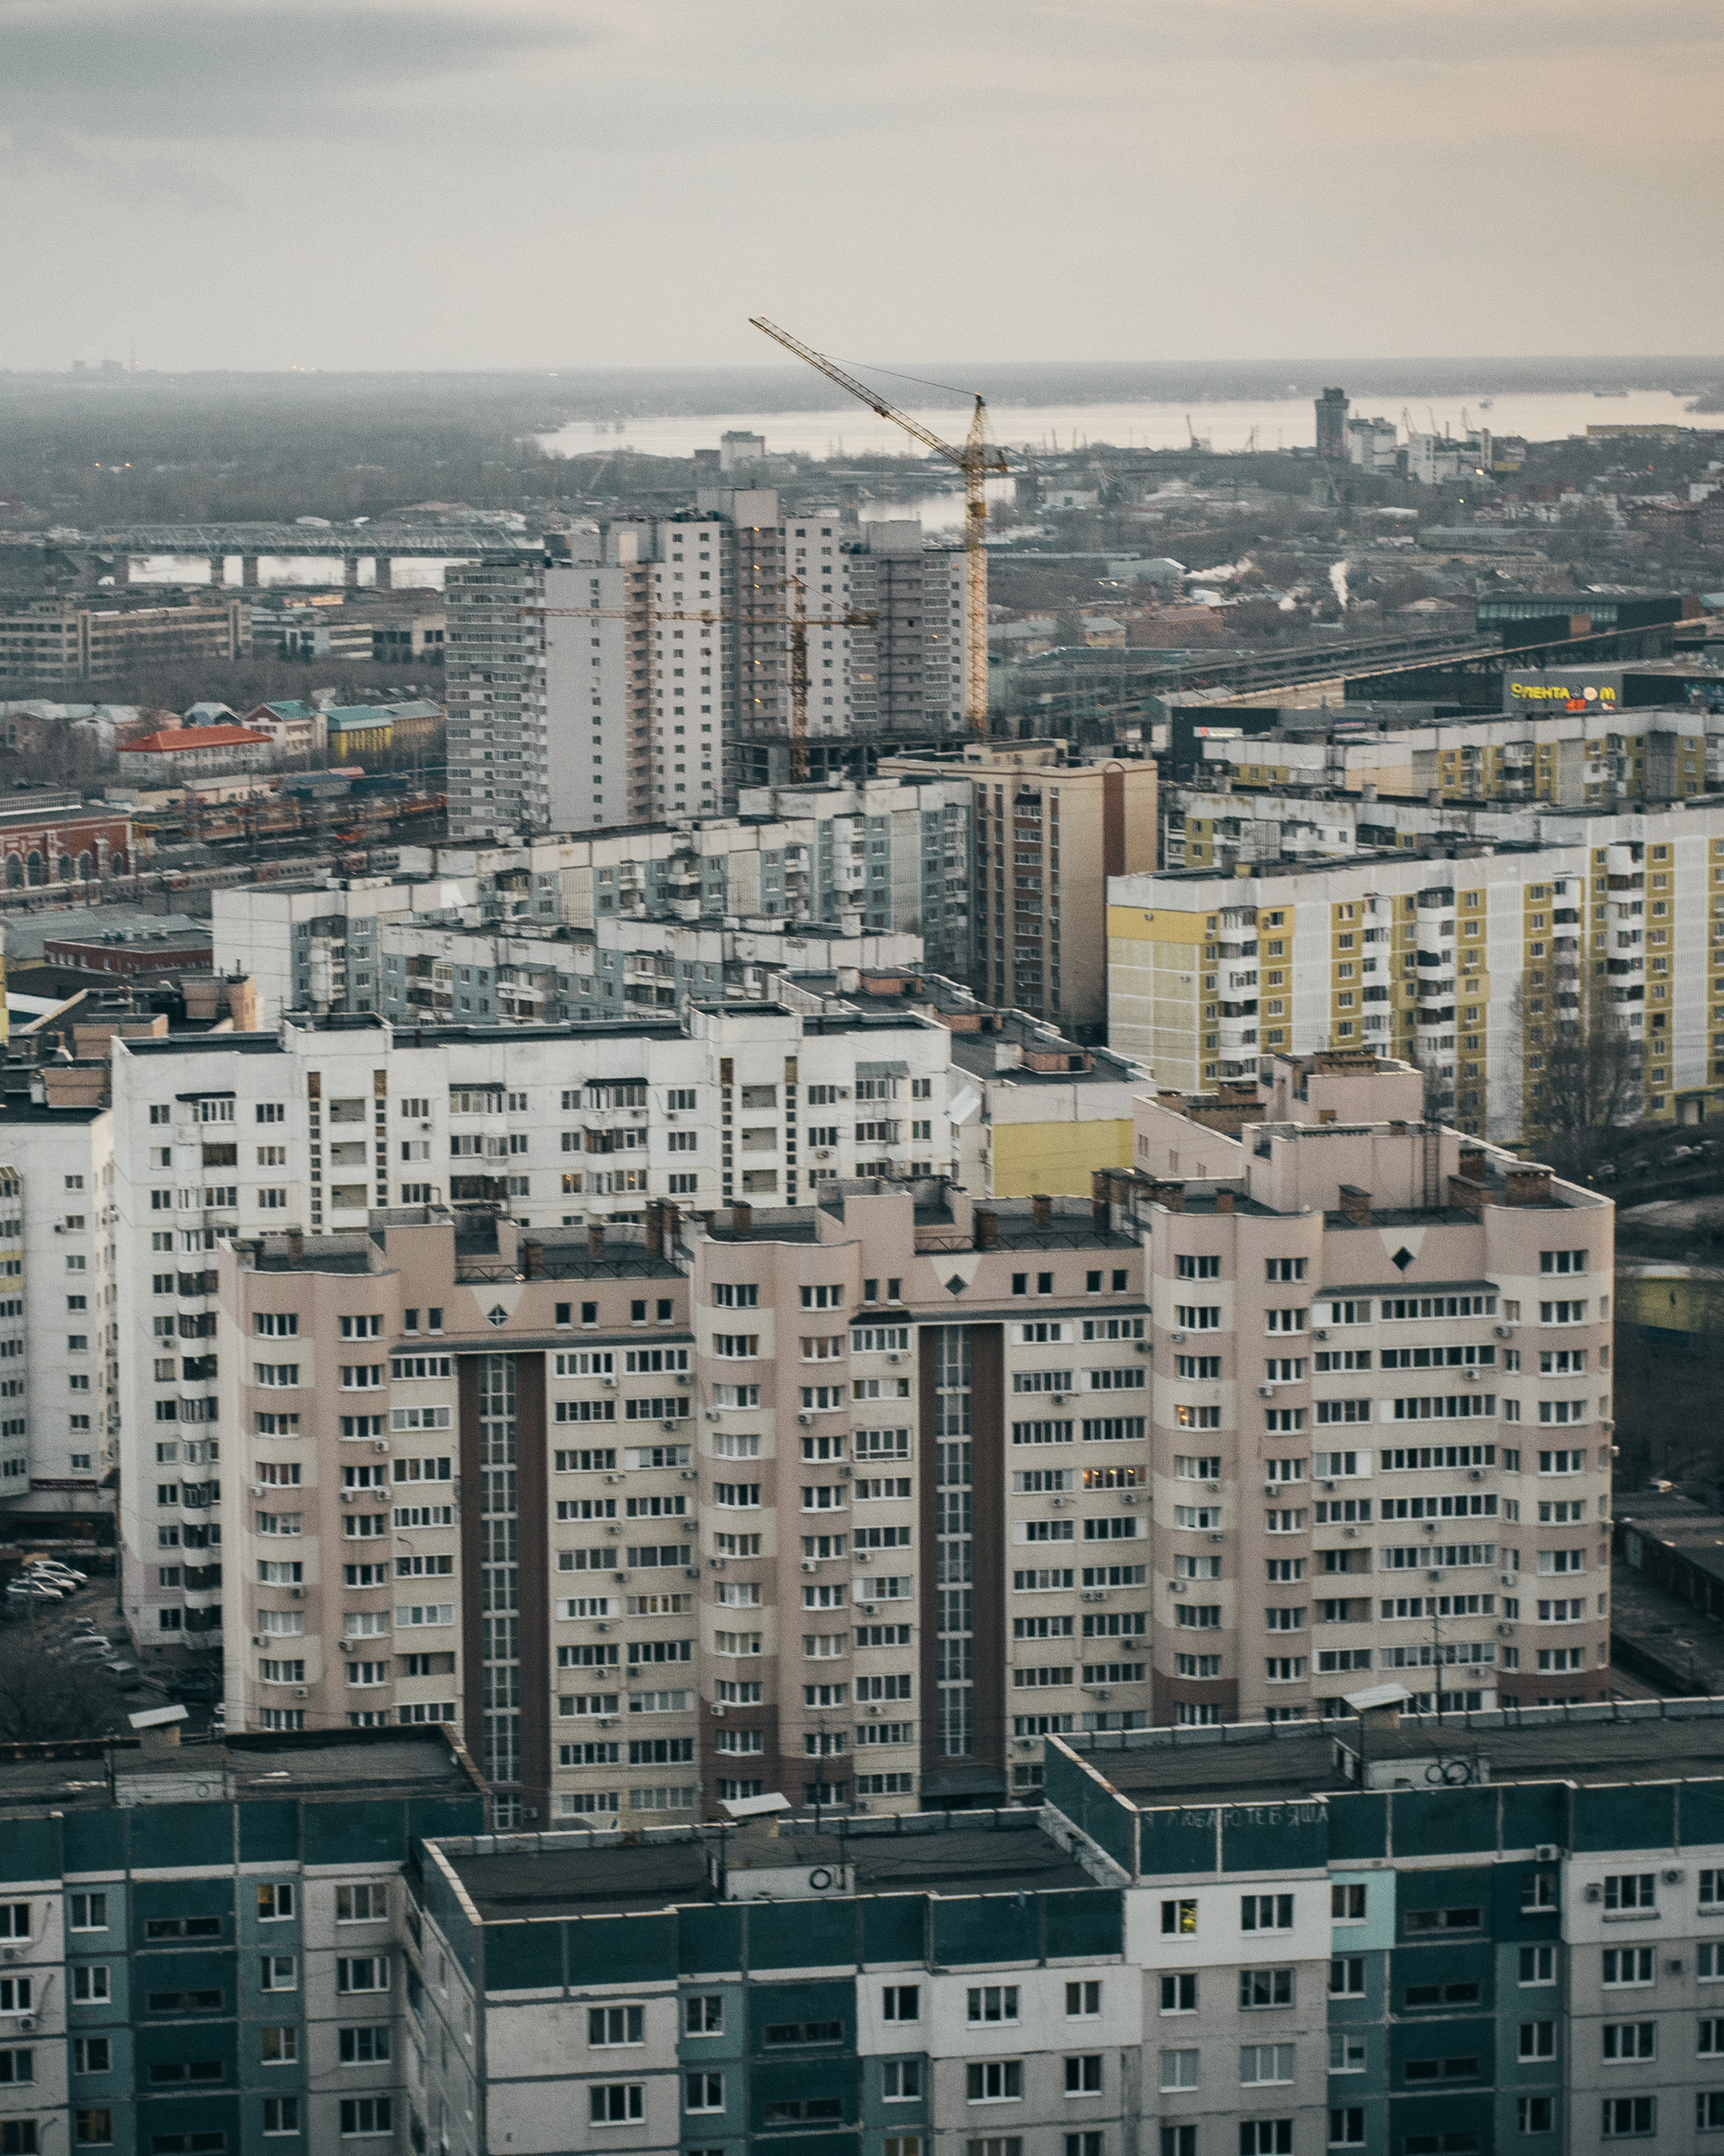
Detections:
[110, 1004, 953, 1648]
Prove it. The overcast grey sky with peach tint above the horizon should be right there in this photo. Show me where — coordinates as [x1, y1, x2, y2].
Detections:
[0, 0, 1724, 369]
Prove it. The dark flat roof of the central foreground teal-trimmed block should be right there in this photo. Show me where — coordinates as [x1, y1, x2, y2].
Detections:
[439, 1809, 1094, 1921]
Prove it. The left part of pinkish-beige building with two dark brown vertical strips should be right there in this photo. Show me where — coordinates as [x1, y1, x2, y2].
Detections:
[220, 1190, 1151, 1819]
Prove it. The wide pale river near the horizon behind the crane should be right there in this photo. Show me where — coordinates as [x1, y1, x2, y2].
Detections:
[539, 388, 1724, 526]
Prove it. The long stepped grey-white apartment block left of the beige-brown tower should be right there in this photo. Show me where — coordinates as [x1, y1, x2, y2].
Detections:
[213, 774, 970, 1024]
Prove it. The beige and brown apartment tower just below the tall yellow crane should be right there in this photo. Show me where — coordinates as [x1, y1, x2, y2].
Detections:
[879, 742, 1157, 1054]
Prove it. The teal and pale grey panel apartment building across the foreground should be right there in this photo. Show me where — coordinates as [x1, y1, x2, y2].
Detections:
[17, 1701, 1724, 2156]
